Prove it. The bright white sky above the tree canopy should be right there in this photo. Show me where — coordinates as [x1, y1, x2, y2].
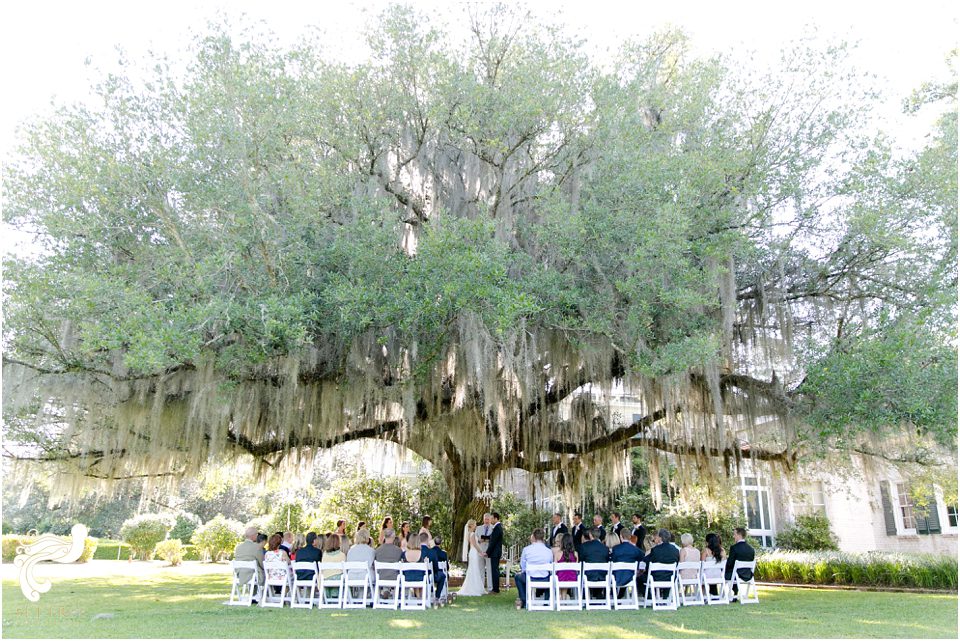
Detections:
[0, 0, 958, 150]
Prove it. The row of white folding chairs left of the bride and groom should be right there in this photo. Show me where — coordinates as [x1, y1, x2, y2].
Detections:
[227, 561, 449, 610]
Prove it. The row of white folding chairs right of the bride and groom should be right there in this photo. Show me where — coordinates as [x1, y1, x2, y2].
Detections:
[525, 561, 760, 610]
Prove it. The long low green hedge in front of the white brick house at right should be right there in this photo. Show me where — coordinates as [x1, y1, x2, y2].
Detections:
[757, 550, 957, 590]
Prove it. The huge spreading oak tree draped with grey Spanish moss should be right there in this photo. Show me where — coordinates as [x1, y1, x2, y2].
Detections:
[4, 8, 957, 552]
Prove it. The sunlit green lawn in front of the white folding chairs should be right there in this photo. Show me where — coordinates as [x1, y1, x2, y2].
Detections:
[2, 570, 957, 639]
